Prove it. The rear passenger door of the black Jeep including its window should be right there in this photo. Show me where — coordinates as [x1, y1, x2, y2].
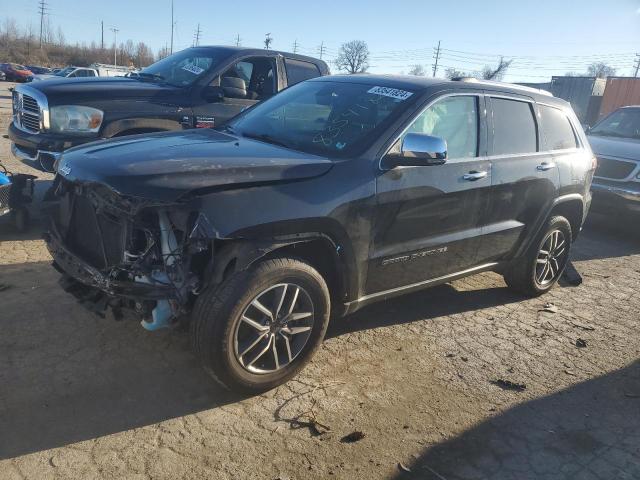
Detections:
[478, 92, 559, 262]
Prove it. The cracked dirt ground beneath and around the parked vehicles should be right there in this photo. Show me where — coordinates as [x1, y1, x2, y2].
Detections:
[0, 83, 640, 480]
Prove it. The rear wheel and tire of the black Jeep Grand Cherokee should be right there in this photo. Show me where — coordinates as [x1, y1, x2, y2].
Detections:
[504, 216, 573, 297]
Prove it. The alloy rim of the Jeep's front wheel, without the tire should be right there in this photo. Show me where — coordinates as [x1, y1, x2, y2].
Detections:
[233, 283, 314, 374]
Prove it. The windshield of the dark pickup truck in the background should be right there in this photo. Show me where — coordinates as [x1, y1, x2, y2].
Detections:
[140, 48, 229, 87]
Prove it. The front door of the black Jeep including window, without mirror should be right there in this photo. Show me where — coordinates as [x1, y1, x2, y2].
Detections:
[366, 94, 492, 294]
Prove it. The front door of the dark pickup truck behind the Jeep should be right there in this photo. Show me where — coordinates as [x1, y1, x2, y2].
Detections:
[192, 57, 278, 128]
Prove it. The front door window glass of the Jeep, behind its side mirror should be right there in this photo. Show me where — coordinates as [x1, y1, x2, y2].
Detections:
[407, 96, 478, 158]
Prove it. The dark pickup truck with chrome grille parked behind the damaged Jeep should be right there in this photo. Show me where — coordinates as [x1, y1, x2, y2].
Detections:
[9, 47, 329, 170]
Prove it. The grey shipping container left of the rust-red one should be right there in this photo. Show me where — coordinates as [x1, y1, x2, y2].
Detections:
[551, 77, 607, 125]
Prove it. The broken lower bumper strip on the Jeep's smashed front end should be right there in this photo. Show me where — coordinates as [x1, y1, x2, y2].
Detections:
[44, 226, 177, 301]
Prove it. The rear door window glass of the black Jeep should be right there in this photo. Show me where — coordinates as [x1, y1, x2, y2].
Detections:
[491, 98, 538, 155]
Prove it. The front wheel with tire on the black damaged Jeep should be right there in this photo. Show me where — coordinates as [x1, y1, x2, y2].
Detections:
[190, 258, 330, 394]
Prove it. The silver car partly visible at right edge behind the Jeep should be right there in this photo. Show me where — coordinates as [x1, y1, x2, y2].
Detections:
[588, 105, 640, 213]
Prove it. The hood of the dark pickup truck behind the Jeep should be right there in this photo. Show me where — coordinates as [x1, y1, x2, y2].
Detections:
[24, 75, 180, 101]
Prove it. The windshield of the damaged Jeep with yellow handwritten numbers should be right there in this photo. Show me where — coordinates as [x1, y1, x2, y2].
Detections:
[229, 81, 415, 158]
